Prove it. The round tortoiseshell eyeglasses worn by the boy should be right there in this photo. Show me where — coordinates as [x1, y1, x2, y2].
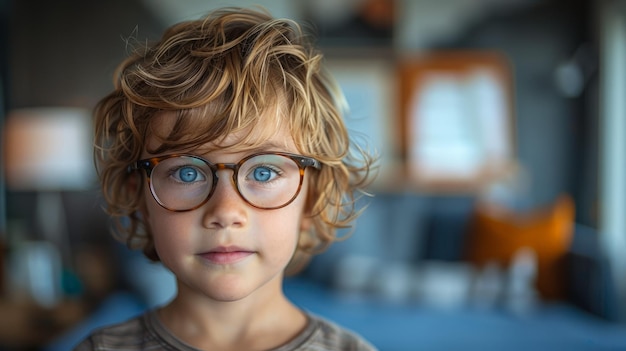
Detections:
[129, 152, 321, 212]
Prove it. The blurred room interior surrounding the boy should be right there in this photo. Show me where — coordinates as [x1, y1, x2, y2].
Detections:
[0, 0, 626, 350]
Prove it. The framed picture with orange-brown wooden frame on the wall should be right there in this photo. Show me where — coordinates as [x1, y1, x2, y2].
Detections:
[398, 51, 515, 191]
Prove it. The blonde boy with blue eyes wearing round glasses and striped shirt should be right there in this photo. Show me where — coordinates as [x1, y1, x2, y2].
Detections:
[76, 8, 374, 351]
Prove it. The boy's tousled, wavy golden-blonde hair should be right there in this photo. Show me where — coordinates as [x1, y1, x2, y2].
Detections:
[94, 8, 373, 272]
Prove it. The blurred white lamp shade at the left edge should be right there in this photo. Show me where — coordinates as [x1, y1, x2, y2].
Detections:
[4, 107, 95, 191]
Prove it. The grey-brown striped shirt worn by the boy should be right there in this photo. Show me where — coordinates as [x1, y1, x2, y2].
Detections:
[74, 310, 376, 351]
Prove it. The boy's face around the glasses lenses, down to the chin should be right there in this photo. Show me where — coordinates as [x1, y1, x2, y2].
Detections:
[143, 113, 310, 301]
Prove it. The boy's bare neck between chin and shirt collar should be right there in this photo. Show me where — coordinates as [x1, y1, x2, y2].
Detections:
[158, 280, 306, 350]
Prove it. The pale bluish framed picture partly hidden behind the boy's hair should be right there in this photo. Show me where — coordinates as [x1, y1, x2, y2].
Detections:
[326, 58, 402, 189]
